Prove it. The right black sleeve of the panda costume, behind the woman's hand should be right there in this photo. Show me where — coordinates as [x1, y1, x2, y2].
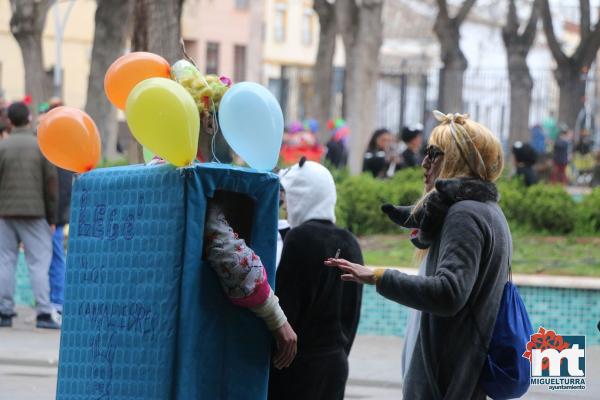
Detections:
[341, 237, 363, 355]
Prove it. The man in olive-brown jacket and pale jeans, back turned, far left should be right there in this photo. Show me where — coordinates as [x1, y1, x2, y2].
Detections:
[0, 102, 60, 329]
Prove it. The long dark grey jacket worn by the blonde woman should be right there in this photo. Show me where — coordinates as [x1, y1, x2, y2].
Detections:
[377, 180, 512, 400]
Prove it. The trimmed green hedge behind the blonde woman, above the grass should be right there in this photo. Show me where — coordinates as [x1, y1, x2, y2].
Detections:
[334, 168, 600, 235]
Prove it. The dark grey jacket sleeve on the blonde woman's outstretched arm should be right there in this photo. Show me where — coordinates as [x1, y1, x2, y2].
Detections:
[377, 211, 484, 317]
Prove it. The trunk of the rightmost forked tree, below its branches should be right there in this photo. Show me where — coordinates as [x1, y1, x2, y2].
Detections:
[555, 65, 586, 129]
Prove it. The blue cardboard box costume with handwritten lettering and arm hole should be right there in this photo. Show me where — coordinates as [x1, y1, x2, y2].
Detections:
[57, 164, 279, 400]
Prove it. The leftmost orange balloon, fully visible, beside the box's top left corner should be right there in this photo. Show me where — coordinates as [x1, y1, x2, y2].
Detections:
[38, 106, 102, 172]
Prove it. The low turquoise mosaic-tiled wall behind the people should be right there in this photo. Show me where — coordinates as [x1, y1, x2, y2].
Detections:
[15, 254, 600, 345]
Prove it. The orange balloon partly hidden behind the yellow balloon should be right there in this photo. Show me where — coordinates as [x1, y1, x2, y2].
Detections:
[104, 51, 171, 110]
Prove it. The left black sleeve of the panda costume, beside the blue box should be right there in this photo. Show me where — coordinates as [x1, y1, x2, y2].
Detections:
[275, 229, 306, 328]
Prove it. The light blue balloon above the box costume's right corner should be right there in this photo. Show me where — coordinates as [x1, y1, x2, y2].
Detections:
[219, 82, 283, 171]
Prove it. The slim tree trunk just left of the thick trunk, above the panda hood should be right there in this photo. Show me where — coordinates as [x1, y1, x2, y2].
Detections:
[311, 0, 337, 143]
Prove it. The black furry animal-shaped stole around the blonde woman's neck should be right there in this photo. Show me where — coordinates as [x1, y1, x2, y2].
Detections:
[381, 178, 499, 249]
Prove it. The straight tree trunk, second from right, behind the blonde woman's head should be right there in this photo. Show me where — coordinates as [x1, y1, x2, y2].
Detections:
[508, 56, 533, 146]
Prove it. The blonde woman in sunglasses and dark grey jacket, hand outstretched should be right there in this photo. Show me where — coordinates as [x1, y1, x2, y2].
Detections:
[325, 112, 512, 400]
